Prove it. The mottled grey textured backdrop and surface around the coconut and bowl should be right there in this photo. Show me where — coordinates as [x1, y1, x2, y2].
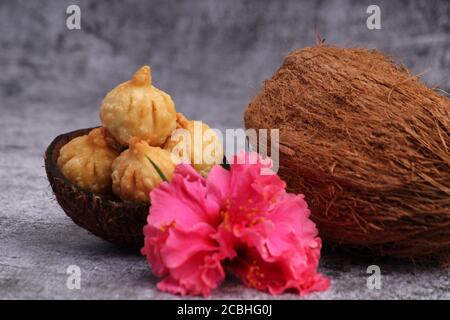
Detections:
[0, 0, 450, 299]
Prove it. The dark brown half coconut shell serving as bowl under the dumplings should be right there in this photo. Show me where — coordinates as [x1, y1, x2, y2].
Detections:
[45, 128, 149, 248]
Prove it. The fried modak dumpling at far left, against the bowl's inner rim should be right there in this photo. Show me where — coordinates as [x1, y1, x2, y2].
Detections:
[58, 128, 119, 193]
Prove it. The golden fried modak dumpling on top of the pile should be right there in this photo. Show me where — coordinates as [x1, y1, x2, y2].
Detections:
[100, 66, 176, 146]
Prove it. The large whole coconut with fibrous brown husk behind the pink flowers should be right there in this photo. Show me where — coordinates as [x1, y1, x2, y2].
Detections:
[244, 45, 450, 262]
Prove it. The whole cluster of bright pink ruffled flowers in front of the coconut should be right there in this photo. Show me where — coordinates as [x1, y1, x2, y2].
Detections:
[142, 153, 329, 295]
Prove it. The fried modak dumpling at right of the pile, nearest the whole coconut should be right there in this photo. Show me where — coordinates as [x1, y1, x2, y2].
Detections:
[164, 113, 223, 177]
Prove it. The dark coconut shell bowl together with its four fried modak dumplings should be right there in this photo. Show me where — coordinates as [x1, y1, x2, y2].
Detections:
[45, 66, 223, 247]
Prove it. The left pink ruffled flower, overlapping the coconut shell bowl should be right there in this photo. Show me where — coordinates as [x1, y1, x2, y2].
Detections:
[142, 165, 225, 296]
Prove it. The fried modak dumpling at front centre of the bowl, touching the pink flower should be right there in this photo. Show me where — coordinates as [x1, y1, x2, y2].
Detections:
[112, 138, 175, 203]
